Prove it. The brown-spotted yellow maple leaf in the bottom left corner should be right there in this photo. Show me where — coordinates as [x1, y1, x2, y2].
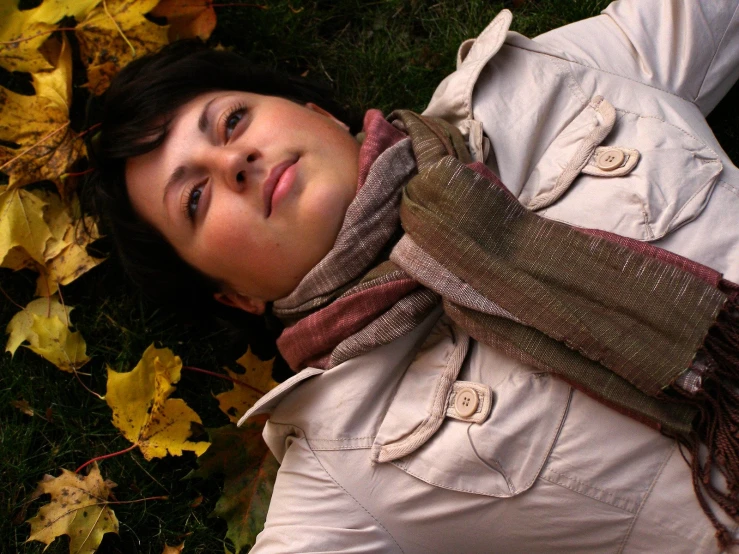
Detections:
[27, 464, 118, 554]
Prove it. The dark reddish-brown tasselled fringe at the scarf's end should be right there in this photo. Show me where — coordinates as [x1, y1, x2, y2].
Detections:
[674, 281, 739, 549]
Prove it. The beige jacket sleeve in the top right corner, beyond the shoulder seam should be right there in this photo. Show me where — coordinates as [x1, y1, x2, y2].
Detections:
[534, 0, 739, 115]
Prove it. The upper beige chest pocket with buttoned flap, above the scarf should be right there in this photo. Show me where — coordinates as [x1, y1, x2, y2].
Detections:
[520, 98, 723, 240]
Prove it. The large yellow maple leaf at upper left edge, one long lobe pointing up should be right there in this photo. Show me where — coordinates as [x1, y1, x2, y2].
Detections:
[0, 37, 85, 193]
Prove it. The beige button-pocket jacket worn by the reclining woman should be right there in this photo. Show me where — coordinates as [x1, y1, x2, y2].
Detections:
[244, 0, 739, 554]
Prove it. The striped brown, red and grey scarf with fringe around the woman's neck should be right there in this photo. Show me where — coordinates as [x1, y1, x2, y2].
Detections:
[273, 111, 739, 547]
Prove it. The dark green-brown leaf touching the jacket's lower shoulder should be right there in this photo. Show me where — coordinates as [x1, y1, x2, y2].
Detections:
[186, 417, 279, 554]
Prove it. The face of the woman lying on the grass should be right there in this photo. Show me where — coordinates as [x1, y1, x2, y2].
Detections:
[126, 91, 359, 313]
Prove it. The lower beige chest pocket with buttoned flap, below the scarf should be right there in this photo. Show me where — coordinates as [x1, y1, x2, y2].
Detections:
[373, 320, 570, 498]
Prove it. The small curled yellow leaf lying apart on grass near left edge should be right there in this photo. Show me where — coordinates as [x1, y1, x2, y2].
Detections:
[5, 297, 90, 373]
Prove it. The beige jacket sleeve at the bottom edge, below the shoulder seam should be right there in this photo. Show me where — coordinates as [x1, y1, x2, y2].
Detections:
[250, 438, 402, 554]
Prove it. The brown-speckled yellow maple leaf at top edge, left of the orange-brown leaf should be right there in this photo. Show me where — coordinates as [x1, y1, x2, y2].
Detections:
[75, 0, 167, 95]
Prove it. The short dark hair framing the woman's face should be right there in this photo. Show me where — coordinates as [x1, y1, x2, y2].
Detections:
[85, 40, 361, 315]
